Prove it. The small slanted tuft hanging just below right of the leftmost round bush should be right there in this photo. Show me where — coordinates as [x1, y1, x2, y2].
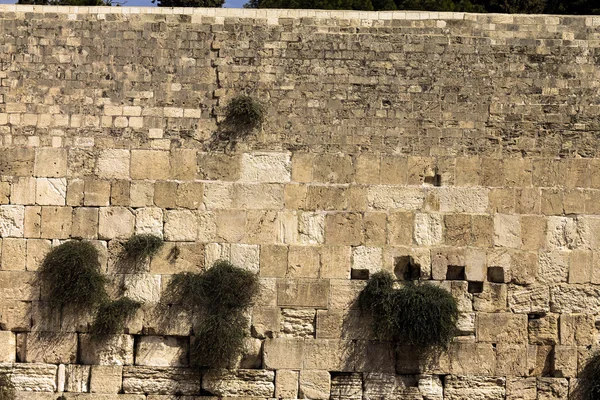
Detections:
[91, 297, 142, 338]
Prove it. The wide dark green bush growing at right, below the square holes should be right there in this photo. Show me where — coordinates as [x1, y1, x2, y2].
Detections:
[358, 272, 458, 349]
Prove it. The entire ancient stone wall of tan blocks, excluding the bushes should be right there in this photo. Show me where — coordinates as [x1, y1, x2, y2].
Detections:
[0, 5, 600, 400]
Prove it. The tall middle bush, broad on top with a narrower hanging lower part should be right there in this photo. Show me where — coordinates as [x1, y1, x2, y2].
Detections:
[167, 261, 259, 367]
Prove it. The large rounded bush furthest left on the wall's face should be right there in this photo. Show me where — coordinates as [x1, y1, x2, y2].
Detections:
[38, 241, 107, 308]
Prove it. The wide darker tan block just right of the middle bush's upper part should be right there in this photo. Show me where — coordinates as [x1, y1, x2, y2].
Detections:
[277, 279, 329, 308]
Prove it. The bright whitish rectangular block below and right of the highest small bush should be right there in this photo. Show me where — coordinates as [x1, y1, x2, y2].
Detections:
[240, 153, 292, 183]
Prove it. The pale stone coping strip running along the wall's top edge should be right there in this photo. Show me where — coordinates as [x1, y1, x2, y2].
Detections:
[0, 4, 600, 26]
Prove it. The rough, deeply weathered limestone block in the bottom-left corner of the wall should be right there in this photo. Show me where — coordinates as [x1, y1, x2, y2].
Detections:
[0, 363, 58, 390]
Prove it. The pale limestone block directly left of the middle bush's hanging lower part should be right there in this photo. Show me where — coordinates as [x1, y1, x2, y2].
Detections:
[135, 336, 189, 367]
